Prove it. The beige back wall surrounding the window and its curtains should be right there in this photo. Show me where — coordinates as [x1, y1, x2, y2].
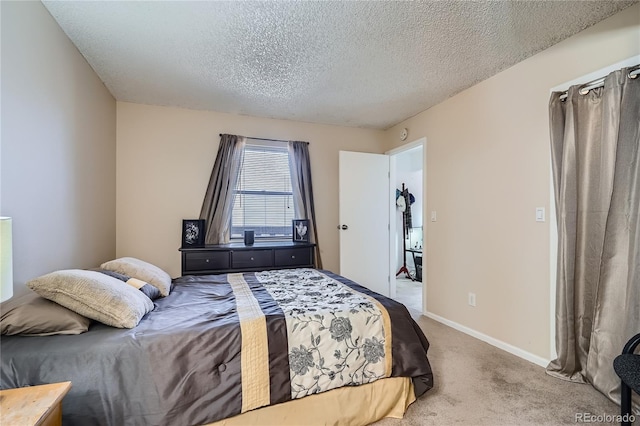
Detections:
[116, 102, 384, 277]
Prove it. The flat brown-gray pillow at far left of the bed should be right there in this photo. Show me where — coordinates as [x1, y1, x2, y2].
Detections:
[0, 292, 91, 336]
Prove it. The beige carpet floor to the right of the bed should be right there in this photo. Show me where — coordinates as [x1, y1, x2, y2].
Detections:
[375, 309, 640, 426]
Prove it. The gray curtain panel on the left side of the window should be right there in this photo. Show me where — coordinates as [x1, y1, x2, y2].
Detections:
[200, 135, 246, 244]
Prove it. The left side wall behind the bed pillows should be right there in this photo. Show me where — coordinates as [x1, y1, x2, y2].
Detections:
[0, 1, 116, 294]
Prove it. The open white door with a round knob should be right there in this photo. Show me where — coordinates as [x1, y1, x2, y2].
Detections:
[338, 151, 390, 296]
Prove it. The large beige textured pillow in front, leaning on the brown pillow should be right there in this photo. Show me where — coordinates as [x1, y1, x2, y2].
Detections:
[27, 269, 154, 328]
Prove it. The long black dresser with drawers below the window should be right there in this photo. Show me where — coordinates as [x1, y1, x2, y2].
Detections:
[180, 241, 315, 275]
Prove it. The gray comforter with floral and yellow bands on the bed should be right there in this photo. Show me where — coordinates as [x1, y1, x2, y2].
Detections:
[0, 270, 433, 425]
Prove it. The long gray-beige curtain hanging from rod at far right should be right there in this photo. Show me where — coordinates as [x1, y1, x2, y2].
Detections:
[547, 65, 640, 410]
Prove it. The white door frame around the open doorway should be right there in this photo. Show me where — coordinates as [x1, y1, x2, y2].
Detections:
[385, 137, 428, 314]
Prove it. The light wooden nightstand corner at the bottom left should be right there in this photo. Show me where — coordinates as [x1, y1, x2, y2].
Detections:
[0, 382, 71, 426]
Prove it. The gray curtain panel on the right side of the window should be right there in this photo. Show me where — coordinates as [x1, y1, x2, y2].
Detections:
[289, 141, 322, 268]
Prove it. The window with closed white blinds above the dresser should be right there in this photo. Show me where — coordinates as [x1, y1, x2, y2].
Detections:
[231, 144, 294, 240]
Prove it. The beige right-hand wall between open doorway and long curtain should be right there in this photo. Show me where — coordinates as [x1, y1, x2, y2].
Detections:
[386, 5, 640, 359]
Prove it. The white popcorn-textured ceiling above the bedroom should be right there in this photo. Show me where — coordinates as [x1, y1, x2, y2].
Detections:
[43, 0, 635, 129]
